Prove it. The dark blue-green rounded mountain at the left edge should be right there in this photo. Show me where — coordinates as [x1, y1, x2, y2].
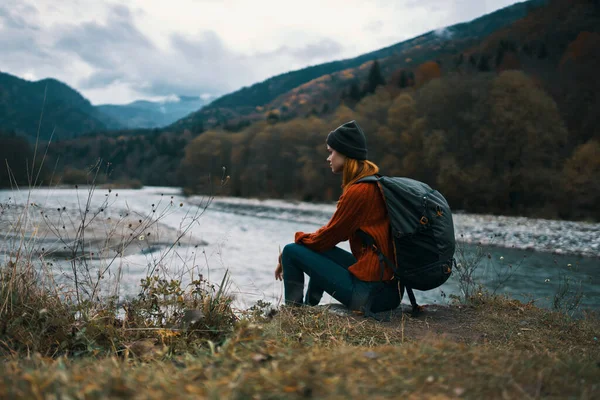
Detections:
[0, 72, 121, 140]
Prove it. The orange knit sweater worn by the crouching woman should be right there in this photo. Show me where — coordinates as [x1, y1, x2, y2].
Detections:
[295, 183, 394, 281]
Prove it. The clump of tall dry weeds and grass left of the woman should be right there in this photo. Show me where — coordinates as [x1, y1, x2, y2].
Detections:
[0, 263, 237, 360]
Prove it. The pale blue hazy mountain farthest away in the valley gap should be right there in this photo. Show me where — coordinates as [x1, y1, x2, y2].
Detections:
[97, 96, 211, 129]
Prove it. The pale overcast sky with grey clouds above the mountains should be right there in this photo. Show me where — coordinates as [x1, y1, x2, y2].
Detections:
[0, 0, 517, 104]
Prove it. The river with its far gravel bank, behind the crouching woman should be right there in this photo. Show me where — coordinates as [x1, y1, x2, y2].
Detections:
[0, 187, 600, 310]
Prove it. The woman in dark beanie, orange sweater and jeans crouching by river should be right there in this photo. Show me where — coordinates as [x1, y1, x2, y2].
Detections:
[275, 121, 400, 313]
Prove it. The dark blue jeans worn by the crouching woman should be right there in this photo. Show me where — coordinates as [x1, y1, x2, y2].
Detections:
[281, 243, 401, 312]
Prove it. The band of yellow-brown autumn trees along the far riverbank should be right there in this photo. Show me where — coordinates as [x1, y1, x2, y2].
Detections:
[180, 71, 600, 220]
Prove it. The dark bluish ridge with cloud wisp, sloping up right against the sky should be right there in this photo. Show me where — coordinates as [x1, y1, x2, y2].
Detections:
[168, 0, 547, 132]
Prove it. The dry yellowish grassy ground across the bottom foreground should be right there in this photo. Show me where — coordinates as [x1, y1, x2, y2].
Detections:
[0, 298, 600, 399]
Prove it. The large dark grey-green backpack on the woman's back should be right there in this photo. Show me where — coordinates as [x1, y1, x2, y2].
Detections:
[356, 175, 456, 313]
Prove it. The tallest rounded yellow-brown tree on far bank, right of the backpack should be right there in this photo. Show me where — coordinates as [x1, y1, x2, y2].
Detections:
[478, 71, 567, 212]
